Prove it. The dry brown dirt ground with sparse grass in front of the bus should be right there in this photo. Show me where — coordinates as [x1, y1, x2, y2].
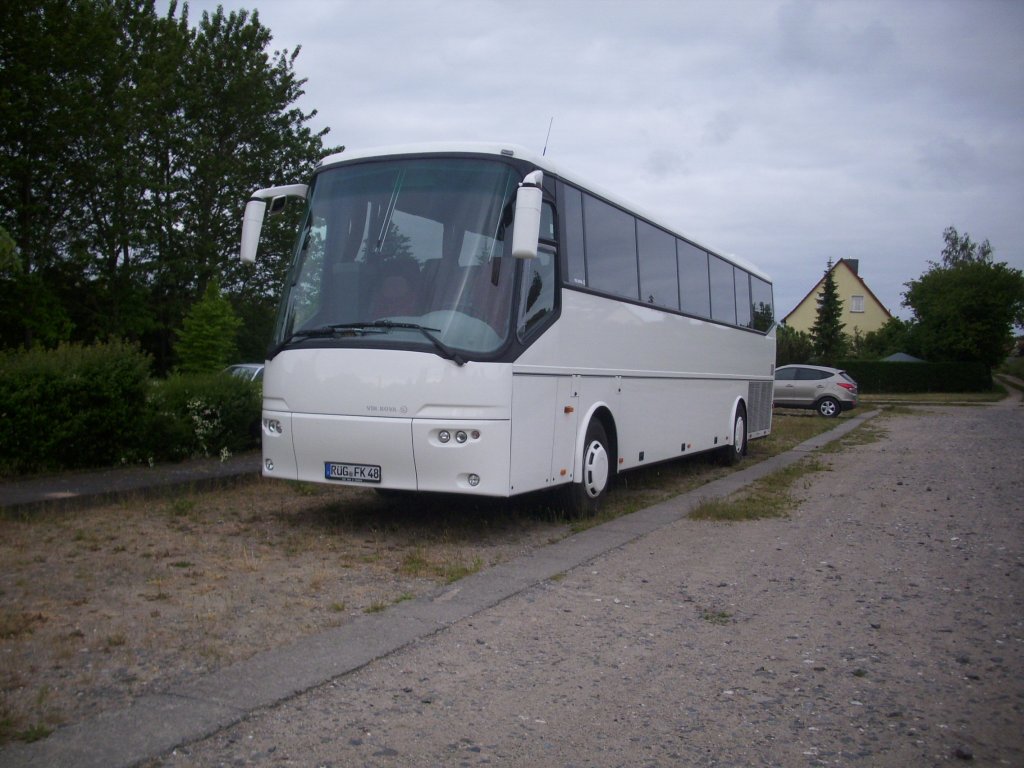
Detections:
[0, 479, 568, 742]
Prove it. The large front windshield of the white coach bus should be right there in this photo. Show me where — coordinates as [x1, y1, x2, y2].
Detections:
[271, 158, 519, 362]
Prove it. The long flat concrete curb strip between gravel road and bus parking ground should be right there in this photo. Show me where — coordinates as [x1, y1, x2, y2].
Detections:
[0, 411, 880, 768]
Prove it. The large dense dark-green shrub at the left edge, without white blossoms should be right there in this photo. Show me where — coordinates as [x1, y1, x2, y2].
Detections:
[0, 342, 150, 472]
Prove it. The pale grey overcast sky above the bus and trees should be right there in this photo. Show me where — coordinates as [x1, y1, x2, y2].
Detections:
[188, 0, 1024, 317]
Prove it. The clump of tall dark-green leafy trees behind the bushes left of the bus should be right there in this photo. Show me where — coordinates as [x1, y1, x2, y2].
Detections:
[0, 0, 331, 371]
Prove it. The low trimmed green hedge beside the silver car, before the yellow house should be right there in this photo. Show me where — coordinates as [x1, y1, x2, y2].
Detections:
[837, 360, 992, 394]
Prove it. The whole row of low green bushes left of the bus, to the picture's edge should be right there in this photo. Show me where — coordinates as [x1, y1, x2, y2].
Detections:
[0, 342, 261, 474]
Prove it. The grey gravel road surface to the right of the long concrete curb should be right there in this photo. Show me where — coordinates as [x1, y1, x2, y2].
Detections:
[153, 398, 1024, 768]
